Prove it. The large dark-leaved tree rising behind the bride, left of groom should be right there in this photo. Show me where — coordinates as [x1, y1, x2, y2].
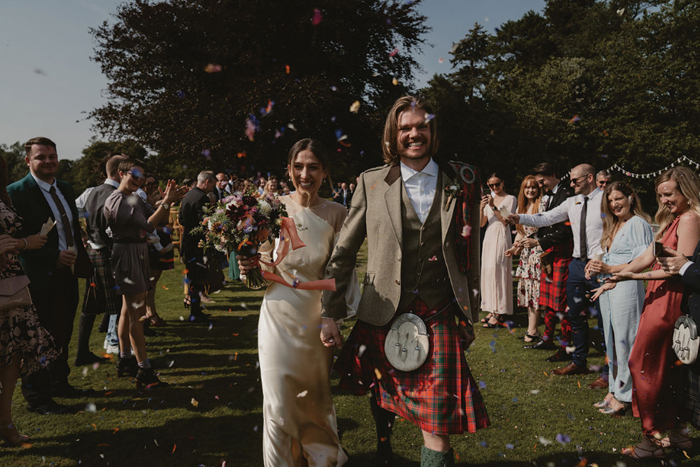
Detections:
[90, 0, 427, 181]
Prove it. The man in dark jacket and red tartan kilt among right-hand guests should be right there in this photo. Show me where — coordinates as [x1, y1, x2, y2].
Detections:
[523, 162, 574, 362]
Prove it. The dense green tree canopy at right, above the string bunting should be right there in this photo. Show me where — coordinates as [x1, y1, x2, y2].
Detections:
[421, 0, 700, 198]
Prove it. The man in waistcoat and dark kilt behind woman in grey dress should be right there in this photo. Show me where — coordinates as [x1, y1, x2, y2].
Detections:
[75, 154, 127, 365]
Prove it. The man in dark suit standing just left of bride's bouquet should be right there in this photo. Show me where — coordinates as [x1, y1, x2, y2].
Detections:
[178, 170, 216, 322]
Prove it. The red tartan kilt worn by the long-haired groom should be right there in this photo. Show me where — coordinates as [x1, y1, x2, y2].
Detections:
[334, 298, 490, 435]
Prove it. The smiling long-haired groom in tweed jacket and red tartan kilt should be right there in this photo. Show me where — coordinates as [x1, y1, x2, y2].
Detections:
[321, 96, 489, 467]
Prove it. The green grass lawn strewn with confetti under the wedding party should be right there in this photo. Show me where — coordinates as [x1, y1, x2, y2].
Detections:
[0, 245, 700, 467]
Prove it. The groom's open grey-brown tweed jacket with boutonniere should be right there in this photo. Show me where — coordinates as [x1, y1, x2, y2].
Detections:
[322, 165, 480, 326]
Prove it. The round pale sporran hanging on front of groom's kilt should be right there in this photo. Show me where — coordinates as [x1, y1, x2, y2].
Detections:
[384, 313, 430, 371]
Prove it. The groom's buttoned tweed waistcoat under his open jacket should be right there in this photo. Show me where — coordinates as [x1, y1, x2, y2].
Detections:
[398, 180, 453, 311]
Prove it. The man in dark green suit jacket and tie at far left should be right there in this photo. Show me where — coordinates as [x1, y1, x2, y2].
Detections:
[7, 137, 94, 414]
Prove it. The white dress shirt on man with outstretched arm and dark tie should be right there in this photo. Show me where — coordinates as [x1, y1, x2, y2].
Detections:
[520, 188, 603, 258]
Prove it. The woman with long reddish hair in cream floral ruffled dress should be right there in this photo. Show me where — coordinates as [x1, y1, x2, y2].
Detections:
[505, 175, 546, 343]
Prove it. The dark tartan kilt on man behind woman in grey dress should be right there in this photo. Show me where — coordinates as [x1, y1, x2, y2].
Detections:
[83, 247, 122, 315]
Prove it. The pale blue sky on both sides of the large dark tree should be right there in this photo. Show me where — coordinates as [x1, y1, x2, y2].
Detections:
[0, 0, 545, 159]
